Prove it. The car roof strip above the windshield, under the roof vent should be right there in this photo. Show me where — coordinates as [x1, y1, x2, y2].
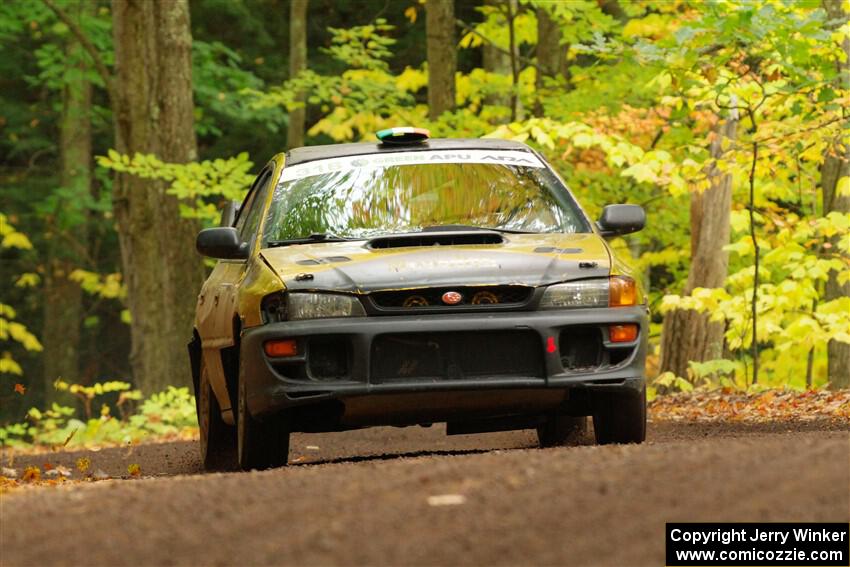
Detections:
[286, 138, 532, 166]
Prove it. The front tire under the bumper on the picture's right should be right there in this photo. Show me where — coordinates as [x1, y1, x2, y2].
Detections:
[593, 387, 646, 445]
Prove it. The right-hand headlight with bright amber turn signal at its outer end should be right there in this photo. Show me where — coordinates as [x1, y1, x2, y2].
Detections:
[540, 276, 637, 309]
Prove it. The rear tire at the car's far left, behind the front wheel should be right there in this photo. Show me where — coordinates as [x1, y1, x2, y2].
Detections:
[197, 359, 236, 471]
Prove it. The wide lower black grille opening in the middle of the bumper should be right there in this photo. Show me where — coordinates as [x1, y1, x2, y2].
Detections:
[372, 331, 544, 382]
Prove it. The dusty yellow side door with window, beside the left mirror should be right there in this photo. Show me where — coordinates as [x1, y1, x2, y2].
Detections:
[196, 167, 273, 424]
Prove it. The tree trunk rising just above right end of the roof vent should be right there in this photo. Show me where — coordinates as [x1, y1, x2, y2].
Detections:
[425, 0, 457, 120]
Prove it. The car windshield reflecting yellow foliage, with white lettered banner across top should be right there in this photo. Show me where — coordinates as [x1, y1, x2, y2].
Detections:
[263, 152, 590, 244]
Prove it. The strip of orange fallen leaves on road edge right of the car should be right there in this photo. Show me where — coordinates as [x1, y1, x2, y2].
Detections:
[649, 388, 850, 422]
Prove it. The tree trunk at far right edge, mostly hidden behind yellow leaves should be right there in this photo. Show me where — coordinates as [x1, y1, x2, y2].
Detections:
[821, 0, 850, 390]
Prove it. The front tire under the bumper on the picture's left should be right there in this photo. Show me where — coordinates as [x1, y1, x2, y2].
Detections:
[236, 372, 289, 471]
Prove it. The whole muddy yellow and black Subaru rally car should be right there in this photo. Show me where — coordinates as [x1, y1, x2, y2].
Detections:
[189, 128, 648, 469]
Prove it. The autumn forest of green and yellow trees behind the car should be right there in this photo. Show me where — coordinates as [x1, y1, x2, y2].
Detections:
[0, 0, 850, 444]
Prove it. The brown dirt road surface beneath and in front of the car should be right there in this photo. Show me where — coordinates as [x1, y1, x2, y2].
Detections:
[0, 422, 850, 567]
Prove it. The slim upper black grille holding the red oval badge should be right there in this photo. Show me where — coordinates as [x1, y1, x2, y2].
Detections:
[369, 285, 533, 311]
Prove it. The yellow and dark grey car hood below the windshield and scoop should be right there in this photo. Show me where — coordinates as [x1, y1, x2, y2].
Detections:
[260, 234, 611, 293]
